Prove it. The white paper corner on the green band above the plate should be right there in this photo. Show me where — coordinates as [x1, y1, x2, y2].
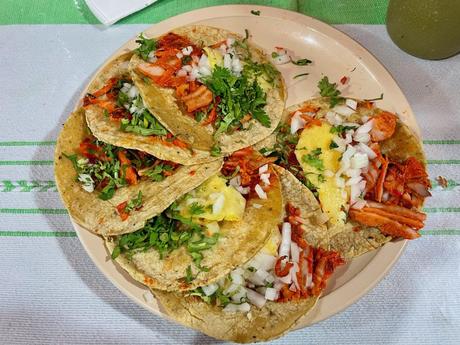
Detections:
[85, 0, 157, 25]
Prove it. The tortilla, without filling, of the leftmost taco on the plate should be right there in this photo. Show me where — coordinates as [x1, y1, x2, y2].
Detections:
[54, 109, 222, 236]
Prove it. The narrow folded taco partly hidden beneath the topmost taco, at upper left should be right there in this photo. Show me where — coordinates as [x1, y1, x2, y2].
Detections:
[83, 52, 216, 165]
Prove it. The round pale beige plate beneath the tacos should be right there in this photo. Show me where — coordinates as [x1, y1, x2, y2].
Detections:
[74, 5, 419, 328]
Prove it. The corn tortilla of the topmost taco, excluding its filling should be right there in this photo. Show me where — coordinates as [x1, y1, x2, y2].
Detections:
[129, 25, 285, 154]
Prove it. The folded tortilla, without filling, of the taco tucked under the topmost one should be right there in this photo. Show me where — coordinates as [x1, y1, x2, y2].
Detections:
[86, 52, 217, 165]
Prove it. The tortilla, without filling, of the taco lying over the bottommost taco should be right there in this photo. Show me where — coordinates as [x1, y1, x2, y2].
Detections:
[106, 167, 282, 291]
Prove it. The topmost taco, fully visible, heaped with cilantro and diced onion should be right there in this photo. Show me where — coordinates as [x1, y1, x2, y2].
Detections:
[130, 25, 285, 156]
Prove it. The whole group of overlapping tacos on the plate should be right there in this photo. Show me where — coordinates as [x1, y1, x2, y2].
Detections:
[55, 25, 430, 342]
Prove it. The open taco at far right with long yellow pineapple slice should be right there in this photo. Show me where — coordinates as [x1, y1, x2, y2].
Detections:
[257, 77, 431, 258]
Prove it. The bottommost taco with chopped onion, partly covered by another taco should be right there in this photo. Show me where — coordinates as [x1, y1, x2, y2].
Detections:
[152, 167, 343, 343]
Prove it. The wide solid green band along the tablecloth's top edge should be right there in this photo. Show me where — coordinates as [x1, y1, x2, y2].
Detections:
[0, 0, 388, 24]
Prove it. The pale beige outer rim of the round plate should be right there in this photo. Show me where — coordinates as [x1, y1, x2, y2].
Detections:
[70, 4, 414, 329]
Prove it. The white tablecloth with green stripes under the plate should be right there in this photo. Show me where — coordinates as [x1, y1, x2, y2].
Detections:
[0, 0, 460, 345]
